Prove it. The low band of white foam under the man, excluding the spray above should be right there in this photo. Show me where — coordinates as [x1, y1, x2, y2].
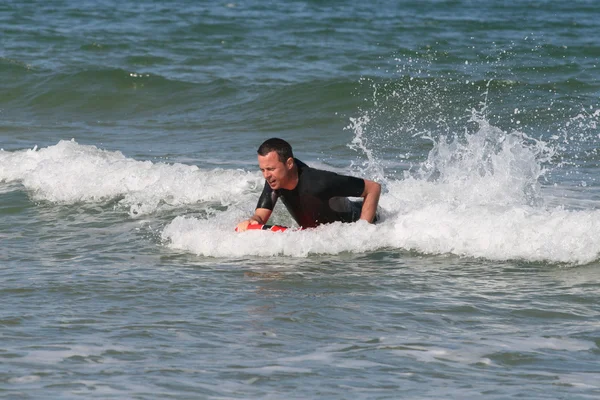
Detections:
[162, 195, 600, 263]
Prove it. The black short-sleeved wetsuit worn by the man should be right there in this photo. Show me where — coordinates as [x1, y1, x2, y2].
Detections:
[256, 158, 365, 228]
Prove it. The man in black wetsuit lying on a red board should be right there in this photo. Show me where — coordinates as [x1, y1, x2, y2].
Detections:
[237, 138, 381, 232]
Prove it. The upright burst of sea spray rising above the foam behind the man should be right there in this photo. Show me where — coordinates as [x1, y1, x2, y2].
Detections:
[412, 110, 554, 205]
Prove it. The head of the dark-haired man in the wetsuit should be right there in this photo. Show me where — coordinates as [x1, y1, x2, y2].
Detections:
[257, 138, 297, 189]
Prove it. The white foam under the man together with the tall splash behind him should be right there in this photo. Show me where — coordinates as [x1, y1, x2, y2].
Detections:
[163, 116, 600, 264]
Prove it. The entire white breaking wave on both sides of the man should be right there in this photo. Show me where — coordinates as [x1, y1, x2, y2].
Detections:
[0, 117, 600, 264]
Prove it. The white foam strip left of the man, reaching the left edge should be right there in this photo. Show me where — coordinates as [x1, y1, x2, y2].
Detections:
[0, 140, 262, 215]
